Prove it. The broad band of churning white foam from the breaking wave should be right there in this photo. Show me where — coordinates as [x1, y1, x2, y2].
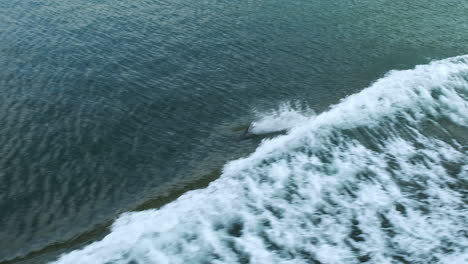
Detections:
[52, 56, 468, 264]
